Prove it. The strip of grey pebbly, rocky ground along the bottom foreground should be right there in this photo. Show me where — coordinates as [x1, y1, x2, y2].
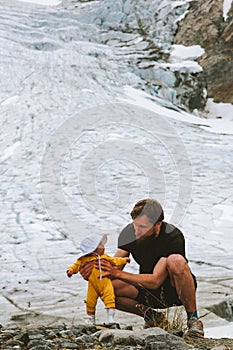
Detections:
[0, 324, 231, 350]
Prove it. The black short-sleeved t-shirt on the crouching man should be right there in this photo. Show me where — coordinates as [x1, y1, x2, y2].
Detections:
[118, 222, 187, 273]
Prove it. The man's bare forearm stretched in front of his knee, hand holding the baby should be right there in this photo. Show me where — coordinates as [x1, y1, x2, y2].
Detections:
[102, 258, 168, 289]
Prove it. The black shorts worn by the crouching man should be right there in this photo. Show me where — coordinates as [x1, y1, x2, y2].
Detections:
[136, 275, 197, 309]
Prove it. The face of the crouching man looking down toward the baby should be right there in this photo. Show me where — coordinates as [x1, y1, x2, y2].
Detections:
[133, 215, 157, 240]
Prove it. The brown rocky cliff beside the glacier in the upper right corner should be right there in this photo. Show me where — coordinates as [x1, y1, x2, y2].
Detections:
[174, 0, 233, 103]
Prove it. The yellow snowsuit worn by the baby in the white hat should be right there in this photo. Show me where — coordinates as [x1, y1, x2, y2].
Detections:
[68, 254, 128, 313]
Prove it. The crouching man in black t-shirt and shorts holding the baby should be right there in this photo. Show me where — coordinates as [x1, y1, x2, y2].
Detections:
[82, 199, 204, 337]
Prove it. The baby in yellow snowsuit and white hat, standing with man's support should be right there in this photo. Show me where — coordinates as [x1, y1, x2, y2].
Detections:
[66, 235, 130, 325]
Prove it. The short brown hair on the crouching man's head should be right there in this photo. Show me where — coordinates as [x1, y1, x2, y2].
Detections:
[130, 198, 164, 224]
